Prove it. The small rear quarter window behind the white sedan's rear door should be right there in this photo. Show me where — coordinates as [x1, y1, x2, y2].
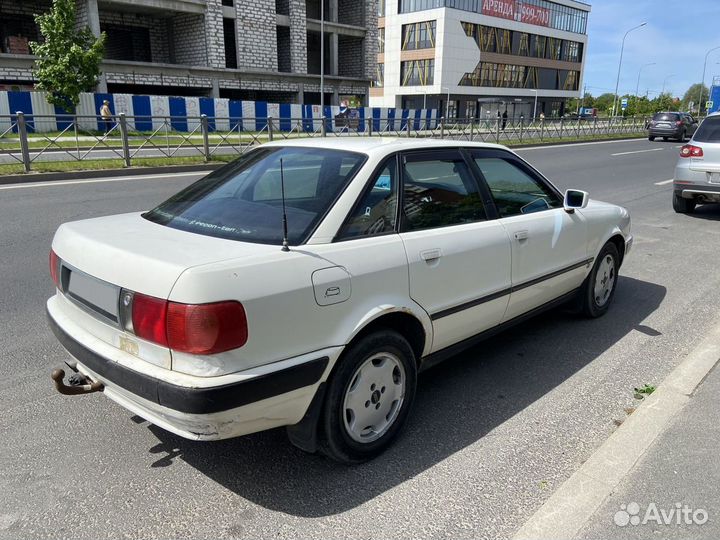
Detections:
[338, 156, 398, 240]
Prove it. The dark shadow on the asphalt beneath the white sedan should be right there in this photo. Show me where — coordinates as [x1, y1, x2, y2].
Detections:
[149, 276, 666, 517]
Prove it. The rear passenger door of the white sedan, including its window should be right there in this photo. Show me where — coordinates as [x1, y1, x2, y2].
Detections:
[400, 149, 511, 351]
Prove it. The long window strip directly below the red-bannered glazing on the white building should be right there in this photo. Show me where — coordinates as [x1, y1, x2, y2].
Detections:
[462, 22, 583, 62]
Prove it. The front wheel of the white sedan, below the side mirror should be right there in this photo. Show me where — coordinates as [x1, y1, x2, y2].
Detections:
[580, 242, 620, 318]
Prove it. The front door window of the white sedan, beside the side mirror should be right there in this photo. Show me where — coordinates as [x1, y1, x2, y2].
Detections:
[475, 156, 562, 217]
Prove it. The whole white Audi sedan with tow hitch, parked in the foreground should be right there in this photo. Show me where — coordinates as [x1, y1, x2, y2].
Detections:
[47, 138, 632, 463]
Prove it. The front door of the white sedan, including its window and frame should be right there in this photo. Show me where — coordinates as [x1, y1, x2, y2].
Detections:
[472, 150, 592, 321]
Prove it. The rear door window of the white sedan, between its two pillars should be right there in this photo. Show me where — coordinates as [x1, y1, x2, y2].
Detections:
[403, 153, 486, 231]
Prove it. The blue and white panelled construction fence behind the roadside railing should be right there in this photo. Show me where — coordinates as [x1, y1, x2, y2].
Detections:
[0, 92, 439, 133]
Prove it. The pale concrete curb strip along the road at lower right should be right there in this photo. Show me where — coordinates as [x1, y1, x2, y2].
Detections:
[512, 318, 720, 540]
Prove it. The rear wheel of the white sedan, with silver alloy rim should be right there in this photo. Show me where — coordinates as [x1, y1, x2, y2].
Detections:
[319, 330, 417, 464]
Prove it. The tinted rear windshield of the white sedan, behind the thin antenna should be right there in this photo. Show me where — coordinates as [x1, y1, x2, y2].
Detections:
[143, 147, 365, 245]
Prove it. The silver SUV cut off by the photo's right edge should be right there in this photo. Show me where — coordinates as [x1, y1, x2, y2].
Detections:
[673, 113, 720, 214]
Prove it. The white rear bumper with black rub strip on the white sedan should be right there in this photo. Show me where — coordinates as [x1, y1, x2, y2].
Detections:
[48, 302, 339, 440]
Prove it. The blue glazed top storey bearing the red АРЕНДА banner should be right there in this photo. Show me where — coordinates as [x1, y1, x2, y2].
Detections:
[398, 0, 588, 34]
